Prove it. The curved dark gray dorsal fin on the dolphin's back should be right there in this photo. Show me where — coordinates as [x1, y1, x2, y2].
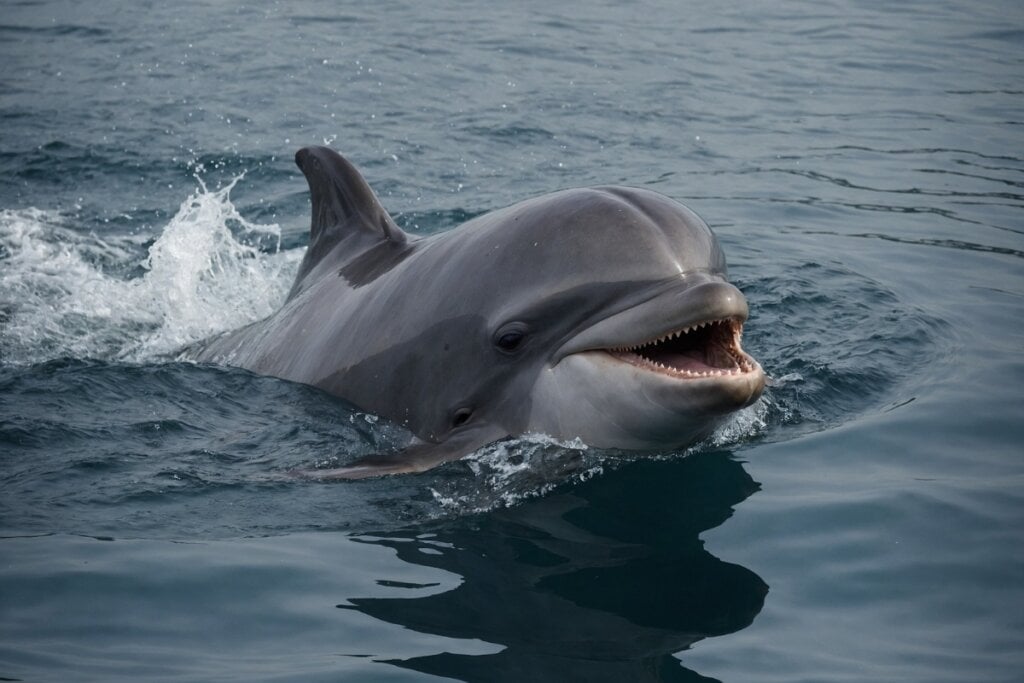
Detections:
[289, 147, 407, 298]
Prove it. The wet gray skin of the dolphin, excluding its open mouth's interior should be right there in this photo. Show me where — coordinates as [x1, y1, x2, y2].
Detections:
[188, 147, 765, 478]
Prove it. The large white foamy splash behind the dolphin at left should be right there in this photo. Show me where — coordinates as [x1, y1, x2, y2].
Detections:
[0, 178, 302, 365]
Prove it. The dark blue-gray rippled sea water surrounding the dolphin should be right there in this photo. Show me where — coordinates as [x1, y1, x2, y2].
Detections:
[0, 0, 1024, 682]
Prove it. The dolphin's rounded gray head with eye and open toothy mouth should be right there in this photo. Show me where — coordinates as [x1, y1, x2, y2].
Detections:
[389, 187, 765, 450]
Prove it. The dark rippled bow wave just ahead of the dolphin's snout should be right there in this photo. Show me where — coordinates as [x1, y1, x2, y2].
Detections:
[729, 255, 955, 444]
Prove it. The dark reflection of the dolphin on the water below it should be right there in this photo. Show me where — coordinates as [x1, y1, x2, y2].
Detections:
[338, 452, 768, 683]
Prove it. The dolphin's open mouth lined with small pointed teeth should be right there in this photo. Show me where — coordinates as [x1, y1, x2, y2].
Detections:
[607, 318, 758, 379]
